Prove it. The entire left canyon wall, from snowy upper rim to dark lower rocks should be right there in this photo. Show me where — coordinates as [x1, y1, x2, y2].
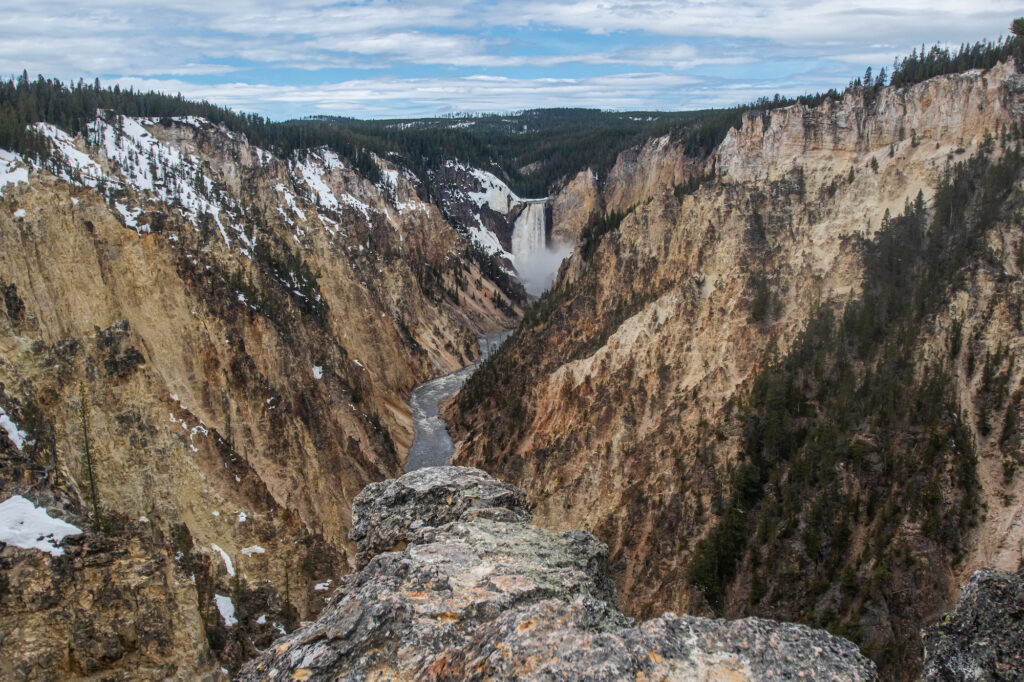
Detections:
[0, 112, 519, 679]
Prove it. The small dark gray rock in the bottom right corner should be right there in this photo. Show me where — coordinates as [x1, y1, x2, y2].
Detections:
[922, 565, 1024, 682]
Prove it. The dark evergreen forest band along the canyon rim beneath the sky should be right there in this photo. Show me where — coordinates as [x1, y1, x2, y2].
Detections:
[0, 27, 1024, 197]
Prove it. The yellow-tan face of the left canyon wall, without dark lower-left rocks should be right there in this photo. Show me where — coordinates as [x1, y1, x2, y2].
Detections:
[0, 115, 518, 677]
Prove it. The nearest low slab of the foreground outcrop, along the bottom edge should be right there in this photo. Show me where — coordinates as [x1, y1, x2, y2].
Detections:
[421, 600, 874, 682]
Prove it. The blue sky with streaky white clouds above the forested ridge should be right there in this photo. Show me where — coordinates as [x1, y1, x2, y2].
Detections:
[0, 0, 1024, 120]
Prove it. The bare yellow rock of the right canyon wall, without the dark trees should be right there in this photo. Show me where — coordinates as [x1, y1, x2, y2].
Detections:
[452, 59, 1024, 667]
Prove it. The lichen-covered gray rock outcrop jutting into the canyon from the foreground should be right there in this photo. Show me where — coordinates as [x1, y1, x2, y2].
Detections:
[237, 467, 877, 680]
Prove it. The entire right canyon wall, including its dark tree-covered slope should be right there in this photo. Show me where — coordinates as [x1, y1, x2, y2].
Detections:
[450, 65, 1024, 677]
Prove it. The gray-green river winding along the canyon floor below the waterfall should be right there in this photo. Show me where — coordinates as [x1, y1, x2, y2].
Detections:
[406, 330, 512, 471]
